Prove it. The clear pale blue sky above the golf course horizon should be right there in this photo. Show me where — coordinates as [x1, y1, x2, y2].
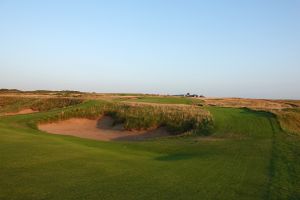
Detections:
[0, 0, 300, 98]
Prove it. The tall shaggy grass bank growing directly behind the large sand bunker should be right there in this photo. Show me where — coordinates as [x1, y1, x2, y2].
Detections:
[39, 101, 212, 135]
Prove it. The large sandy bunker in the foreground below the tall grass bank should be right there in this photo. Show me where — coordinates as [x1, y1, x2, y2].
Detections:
[38, 117, 170, 141]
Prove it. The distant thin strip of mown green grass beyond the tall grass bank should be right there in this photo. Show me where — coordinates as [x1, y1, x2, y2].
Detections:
[125, 96, 203, 105]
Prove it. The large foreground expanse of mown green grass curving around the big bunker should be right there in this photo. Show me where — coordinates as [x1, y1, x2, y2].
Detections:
[0, 102, 300, 200]
